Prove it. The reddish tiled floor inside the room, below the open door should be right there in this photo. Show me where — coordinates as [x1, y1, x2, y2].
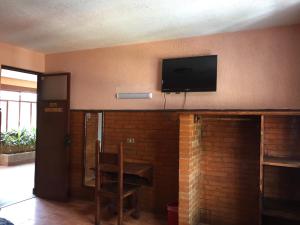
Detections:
[0, 198, 167, 225]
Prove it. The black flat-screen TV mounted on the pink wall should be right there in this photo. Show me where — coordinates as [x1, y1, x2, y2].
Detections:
[162, 55, 218, 92]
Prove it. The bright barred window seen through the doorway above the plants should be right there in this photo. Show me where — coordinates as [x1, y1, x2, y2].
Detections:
[0, 91, 37, 132]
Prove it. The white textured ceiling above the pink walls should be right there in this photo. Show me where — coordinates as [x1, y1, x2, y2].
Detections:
[0, 0, 300, 53]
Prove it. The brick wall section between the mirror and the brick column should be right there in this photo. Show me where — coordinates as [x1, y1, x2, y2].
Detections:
[103, 112, 179, 213]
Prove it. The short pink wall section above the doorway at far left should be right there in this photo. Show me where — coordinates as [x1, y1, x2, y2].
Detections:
[0, 43, 45, 72]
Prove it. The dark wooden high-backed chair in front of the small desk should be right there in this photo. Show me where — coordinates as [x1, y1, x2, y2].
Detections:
[95, 141, 139, 225]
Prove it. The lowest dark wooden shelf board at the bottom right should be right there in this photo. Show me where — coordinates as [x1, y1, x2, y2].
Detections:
[262, 199, 300, 221]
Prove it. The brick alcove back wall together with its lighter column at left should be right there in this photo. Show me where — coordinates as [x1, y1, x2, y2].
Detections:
[179, 115, 260, 225]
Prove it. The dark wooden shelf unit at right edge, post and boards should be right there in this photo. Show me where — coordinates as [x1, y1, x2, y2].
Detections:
[259, 115, 300, 225]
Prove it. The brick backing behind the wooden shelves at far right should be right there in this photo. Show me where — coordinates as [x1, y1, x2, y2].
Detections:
[264, 116, 300, 200]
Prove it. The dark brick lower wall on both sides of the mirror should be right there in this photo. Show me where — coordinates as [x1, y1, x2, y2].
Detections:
[70, 111, 179, 213]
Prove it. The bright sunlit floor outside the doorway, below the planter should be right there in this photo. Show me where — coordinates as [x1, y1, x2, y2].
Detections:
[0, 163, 34, 208]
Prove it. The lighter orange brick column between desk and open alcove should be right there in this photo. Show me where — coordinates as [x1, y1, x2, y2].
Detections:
[179, 114, 201, 225]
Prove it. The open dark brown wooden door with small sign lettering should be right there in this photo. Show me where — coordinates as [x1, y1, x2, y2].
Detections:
[34, 73, 70, 201]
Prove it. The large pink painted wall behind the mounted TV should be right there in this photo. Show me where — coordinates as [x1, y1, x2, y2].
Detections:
[46, 25, 300, 109]
